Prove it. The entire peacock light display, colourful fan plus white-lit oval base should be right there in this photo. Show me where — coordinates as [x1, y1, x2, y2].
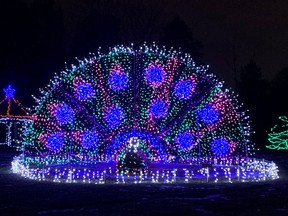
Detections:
[12, 44, 278, 183]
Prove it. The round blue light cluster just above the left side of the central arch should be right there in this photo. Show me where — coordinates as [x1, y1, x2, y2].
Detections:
[105, 106, 124, 128]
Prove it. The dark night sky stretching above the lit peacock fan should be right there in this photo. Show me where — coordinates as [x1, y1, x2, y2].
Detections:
[0, 0, 288, 106]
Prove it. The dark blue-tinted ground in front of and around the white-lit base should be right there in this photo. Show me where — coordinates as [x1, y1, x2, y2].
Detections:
[0, 148, 288, 215]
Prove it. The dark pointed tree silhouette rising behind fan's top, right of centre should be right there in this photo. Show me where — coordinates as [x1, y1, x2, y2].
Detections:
[161, 17, 203, 63]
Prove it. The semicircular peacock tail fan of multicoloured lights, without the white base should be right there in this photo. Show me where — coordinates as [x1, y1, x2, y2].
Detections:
[25, 44, 251, 163]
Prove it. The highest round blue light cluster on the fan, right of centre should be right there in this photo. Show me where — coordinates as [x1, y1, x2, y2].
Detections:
[146, 66, 166, 86]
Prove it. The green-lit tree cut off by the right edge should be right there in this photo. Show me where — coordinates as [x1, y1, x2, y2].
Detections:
[266, 116, 288, 150]
